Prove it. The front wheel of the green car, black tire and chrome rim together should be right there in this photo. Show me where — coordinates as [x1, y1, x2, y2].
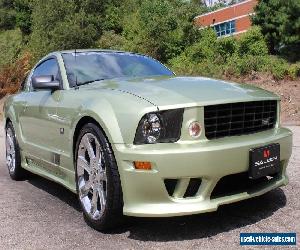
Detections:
[74, 123, 123, 231]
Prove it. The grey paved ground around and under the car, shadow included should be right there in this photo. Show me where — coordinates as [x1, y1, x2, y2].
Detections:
[0, 123, 300, 249]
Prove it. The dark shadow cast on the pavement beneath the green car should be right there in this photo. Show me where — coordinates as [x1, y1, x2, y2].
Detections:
[27, 176, 287, 242]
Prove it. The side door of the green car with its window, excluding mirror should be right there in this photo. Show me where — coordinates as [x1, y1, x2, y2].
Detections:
[19, 57, 61, 165]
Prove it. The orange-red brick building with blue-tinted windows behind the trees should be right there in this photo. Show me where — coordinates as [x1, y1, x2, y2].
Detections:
[194, 0, 257, 37]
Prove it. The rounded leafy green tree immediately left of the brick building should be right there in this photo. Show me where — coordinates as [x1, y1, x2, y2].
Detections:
[122, 0, 203, 62]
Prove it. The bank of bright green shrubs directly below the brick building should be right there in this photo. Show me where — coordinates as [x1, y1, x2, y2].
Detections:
[169, 27, 300, 80]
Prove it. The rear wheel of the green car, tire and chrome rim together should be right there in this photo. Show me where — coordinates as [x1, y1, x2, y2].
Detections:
[5, 122, 27, 181]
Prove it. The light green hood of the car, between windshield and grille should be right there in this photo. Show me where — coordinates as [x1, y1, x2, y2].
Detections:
[91, 77, 279, 108]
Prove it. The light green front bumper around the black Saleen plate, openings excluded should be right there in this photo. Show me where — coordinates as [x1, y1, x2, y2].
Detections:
[114, 128, 292, 217]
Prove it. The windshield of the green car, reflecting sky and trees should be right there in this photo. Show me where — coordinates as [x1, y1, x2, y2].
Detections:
[62, 52, 173, 87]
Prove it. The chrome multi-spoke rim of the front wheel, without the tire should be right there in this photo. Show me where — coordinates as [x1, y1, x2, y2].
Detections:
[76, 133, 107, 220]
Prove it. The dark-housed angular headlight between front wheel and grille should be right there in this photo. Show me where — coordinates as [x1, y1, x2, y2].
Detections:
[134, 109, 183, 144]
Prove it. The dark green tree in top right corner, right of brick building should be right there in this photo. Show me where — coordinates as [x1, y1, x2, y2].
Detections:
[252, 0, 300, 57]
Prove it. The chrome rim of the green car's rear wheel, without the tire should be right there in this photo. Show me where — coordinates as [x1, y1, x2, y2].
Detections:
[6, 128, 16, 173]
